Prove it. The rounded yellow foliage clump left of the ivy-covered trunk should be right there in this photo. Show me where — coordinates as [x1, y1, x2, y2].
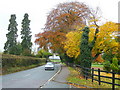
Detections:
[64, 31, 81, 58]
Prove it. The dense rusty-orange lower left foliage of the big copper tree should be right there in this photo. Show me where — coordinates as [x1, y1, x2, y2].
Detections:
[35, 31, 65, 50]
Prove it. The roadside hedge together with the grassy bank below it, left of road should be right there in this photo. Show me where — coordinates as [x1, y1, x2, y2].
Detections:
[0, 54, 46, 75]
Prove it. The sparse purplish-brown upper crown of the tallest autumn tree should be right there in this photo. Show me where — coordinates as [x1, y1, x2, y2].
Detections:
[45, 2, 90, 33]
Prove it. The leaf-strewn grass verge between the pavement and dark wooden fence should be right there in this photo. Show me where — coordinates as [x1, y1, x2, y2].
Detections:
[67, 67, 118, 88]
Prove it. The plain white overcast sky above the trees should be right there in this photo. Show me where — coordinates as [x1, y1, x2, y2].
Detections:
[0, 0, 119, 52]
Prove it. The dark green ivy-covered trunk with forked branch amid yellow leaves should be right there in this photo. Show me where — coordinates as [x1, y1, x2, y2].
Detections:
[77, 27, 100, 76]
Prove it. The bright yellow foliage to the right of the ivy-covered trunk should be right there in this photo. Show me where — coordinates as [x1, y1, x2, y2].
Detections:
[95, 22, 118, 51]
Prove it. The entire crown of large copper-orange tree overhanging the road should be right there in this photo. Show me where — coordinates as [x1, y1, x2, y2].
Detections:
[35, 2, 91, 59]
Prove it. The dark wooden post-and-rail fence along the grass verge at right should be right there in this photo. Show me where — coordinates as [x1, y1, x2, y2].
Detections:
[68, 64, 120, 90]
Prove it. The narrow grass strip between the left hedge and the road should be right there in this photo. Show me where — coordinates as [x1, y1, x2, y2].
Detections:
[0, 63, 45, 75]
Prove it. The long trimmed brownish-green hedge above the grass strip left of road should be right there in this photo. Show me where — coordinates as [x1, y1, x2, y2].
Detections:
[2, 54, 46, 68]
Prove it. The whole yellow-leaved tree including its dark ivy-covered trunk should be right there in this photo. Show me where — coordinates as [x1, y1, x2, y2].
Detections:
[64, 22, 118, 76]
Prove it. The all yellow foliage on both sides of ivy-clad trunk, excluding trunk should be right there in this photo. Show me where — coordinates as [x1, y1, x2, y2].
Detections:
[63, 22, 118, 58]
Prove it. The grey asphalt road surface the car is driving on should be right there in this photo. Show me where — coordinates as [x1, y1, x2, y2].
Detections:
[0, 64, 60, 88]
